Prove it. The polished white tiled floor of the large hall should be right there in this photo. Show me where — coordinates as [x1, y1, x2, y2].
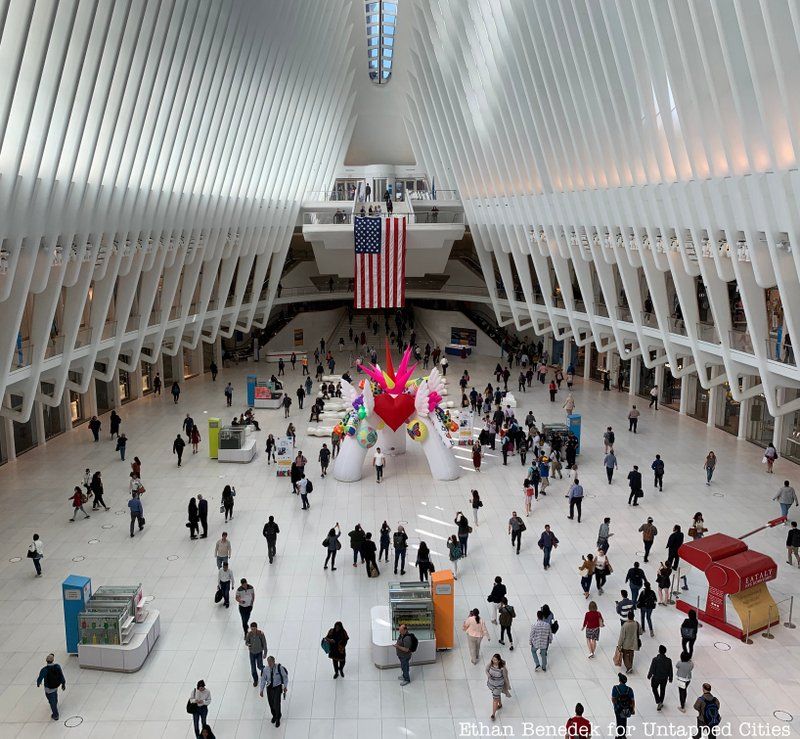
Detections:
[0, 350, 800, 739]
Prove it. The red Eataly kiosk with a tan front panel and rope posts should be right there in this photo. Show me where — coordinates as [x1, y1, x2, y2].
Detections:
[676, 518, 785, 640]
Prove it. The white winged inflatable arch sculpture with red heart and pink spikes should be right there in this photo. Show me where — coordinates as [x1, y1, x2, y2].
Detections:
[333, 345, 460, 482]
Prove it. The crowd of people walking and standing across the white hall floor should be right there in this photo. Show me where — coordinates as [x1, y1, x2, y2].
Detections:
[23, 320, 800, 737]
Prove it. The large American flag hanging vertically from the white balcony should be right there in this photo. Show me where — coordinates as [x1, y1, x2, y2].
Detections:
[353, 216, 406, 308]
